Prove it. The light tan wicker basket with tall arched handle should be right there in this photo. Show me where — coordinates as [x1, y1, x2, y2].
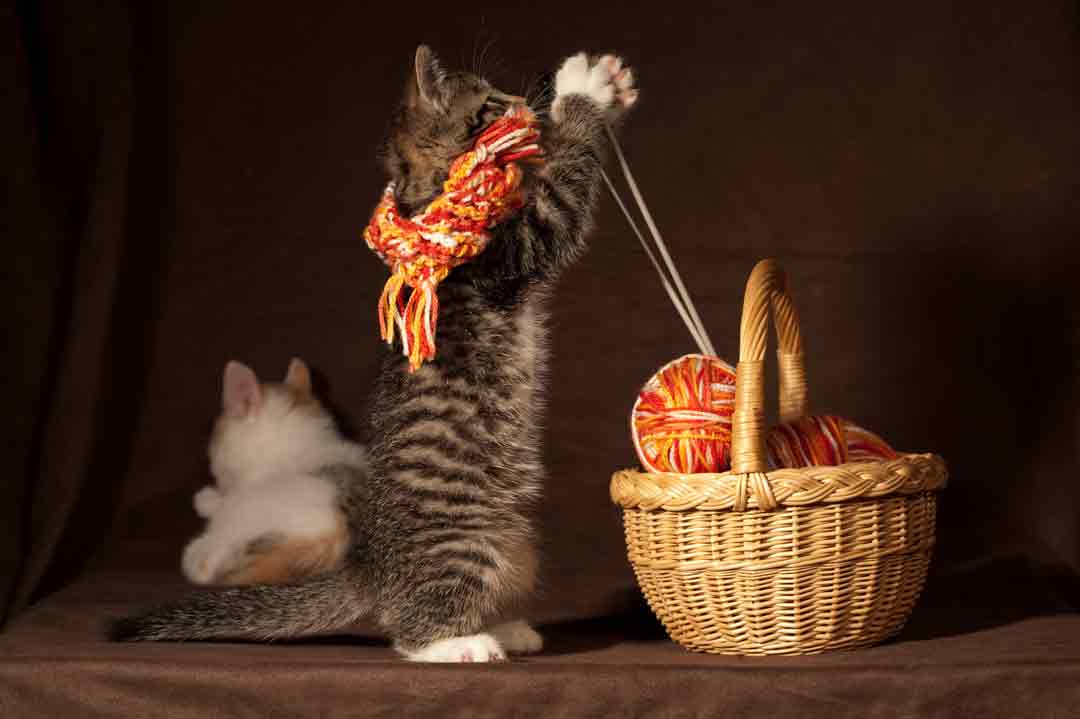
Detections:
[611, 260, 946, 654]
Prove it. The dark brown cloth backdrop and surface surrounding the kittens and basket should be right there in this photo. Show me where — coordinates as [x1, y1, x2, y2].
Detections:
[0, 0, 1080, 717]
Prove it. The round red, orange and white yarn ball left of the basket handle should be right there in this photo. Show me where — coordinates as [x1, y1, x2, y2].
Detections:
[631, 354, 735, 474]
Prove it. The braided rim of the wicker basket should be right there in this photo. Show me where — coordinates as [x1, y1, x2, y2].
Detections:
[610, 453, 948, 512]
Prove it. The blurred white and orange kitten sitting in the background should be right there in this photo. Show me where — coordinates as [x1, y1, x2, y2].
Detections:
[181, 360, 354, 584]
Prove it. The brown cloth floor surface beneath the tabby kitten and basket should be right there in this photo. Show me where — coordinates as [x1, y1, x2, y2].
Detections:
[0, 560, 1080, 719]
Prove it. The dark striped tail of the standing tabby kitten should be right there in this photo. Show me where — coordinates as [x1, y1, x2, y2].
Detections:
[109, 572, 372, 641]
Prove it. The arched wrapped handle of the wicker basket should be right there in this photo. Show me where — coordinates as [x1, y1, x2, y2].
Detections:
[731, 259, 808, 510]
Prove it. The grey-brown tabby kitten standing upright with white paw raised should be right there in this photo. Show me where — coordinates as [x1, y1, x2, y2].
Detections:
[114, 45, 636, 662]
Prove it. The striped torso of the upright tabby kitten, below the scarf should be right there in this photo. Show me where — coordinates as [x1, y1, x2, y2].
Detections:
[369, 283, 545, 652]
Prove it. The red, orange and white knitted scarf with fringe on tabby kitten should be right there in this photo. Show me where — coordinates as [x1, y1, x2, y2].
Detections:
[364, 105, 542, 372]
